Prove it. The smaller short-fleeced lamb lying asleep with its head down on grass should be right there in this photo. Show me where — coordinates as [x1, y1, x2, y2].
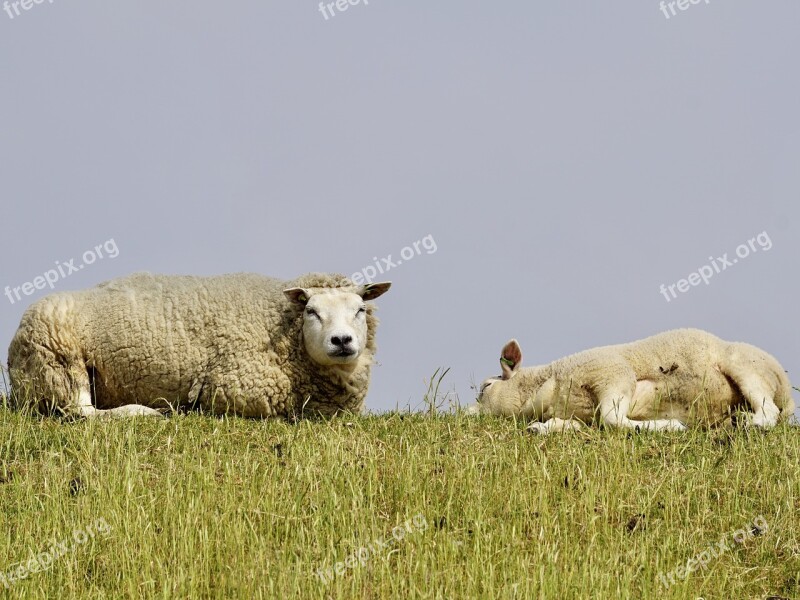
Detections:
[476, 329, 794, 433]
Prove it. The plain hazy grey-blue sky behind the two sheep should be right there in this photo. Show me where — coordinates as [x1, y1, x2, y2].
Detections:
[0, 0, 800, 420]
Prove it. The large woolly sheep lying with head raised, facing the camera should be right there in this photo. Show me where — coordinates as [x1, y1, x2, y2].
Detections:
[8, 273, 391, 417]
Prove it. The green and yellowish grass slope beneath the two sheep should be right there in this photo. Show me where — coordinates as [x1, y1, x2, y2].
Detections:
[0, 409, 800, 599]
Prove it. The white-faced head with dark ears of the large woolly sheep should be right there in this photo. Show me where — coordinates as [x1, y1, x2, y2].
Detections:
[283, 282, 392, 366]
